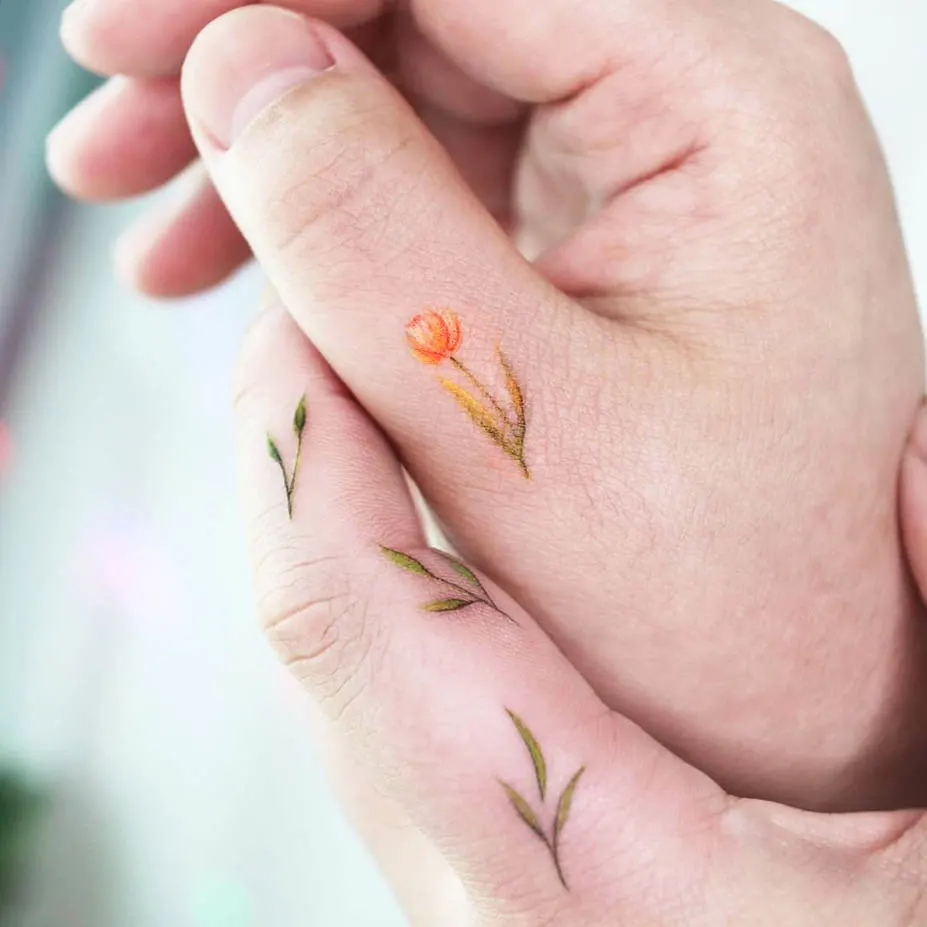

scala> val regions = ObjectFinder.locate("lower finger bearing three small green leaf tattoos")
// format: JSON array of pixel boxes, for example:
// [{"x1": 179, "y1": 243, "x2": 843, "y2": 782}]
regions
[{"x1": 236, "y1": 298, "x2": 725, "y2": 924}]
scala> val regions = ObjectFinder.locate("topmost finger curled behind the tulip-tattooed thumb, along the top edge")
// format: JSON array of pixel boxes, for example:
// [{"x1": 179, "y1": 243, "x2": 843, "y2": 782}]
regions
[{"x1": 62, "y1": 0, "x2": 700, "y2": 103}]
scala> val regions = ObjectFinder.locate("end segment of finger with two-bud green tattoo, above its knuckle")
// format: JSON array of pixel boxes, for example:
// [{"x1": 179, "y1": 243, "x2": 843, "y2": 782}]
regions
[{"x1": 234, "y1": 288, "x2": 421, "y2": 588}]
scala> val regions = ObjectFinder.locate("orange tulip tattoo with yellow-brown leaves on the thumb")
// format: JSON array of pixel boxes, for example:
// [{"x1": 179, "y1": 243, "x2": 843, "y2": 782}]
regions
[{"x1": 406, "y1": 309, "x2": 531, "y2": 479}]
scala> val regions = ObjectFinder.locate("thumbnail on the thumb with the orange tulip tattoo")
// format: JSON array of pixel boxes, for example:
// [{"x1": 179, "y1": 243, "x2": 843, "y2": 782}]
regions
[{"x1": 194, "y1": 8, "x2": 335, "y2": 148}]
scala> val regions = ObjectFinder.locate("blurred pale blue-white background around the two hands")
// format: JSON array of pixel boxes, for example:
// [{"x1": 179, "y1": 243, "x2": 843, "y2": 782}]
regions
[{"x1": 0, "y1": 0, "x2": 927, "y2": 927}]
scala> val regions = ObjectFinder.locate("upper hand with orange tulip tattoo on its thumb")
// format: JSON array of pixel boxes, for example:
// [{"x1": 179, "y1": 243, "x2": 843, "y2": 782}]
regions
[{"x1": 51, "y1": 0, "x2": 927, "y2": 809}]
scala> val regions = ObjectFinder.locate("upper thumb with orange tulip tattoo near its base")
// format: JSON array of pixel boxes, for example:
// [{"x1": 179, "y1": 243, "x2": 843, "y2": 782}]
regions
[{"x1": 183, "y1": 6, "x2": 607, "y2": 492}]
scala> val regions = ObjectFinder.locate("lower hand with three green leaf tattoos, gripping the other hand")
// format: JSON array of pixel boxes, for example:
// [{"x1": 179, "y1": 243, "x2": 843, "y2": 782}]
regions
[{"x1": 230, "y1": 306, "x2": 927, "y2": 927}]
